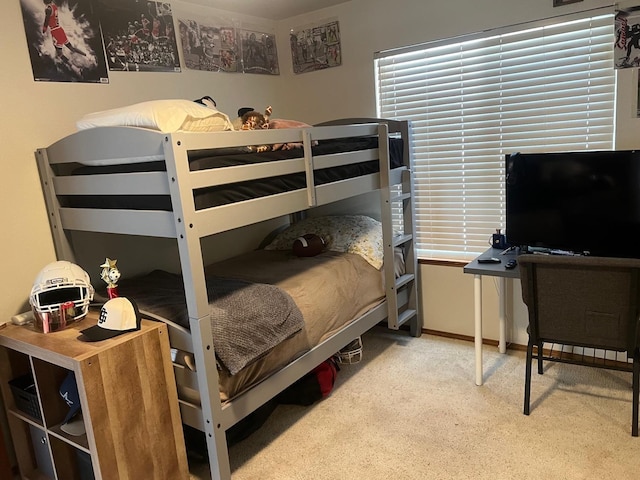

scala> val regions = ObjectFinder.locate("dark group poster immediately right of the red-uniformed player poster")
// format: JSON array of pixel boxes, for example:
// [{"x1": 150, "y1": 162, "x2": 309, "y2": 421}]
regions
[{"x1": 93, "y1": 0, "x2": 180, "y2": 72}]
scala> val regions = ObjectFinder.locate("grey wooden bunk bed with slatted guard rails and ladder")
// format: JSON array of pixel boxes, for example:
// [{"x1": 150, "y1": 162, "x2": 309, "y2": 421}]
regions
[{"x1": 36, "y1": 118, "x2": 422, "y2": 479}]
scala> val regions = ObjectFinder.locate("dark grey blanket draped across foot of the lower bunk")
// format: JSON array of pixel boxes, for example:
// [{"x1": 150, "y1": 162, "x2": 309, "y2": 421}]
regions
[{"x1": 109, "y1": 270, "x2": 304, "y2": 375}]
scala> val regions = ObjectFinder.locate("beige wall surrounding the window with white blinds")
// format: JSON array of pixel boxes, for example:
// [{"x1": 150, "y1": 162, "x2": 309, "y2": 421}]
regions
[{"x1": 278, "y1": 0, "x2": 640, "y2": 344}]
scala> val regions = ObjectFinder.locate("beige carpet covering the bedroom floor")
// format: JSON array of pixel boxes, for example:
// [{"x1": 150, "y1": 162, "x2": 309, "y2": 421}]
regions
[{"x1": 191, "y1": 328, "x2": 640, "y2": 480}]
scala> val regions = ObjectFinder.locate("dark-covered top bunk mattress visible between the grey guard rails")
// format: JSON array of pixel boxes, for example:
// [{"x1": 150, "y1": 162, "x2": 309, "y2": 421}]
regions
[{"x1": 58, "y1": 136, "x2": 404, "y2": 211}]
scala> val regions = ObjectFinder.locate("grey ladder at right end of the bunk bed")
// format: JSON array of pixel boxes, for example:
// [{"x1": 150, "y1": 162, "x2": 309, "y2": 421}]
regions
[{"x1": 379, "y1": 124, "x2": 422, "y2": 337}]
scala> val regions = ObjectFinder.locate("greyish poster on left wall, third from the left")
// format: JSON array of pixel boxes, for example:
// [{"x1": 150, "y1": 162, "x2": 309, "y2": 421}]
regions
[{"x1": 178, "y1": 19, "x2": 240, "y2": 72}]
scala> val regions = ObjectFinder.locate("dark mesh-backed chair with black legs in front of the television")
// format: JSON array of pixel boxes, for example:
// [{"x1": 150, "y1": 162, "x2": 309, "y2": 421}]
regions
[{"x1": 518, "y1": 254, "x2": 640, "y2": 437}]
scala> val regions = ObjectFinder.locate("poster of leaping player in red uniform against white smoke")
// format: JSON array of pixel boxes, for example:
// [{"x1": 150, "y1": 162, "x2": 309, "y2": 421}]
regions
[{"x1": 20, "y1": 0, "x2": 109, "y2": 83}]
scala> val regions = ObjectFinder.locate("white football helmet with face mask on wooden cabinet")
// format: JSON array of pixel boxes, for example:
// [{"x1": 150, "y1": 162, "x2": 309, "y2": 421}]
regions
[{"x1": 29, "y1": 260, "x2": 94, "y2": 333}]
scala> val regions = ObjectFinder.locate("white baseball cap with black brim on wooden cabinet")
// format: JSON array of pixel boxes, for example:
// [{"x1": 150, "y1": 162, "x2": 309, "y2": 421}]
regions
[{"x1": 80, "y1": 297, "x2": 141, "y2": 342}]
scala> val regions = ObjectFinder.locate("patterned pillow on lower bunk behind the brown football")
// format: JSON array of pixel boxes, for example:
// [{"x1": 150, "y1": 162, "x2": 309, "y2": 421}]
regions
[{"x1": 265, "y1": 215, "x2": 383, "y2": 270}]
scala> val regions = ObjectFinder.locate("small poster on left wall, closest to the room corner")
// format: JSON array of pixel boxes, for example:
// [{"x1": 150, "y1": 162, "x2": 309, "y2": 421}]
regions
[{"x1": 239, "y1": 29, "x2": 280, "y2": 75}]
